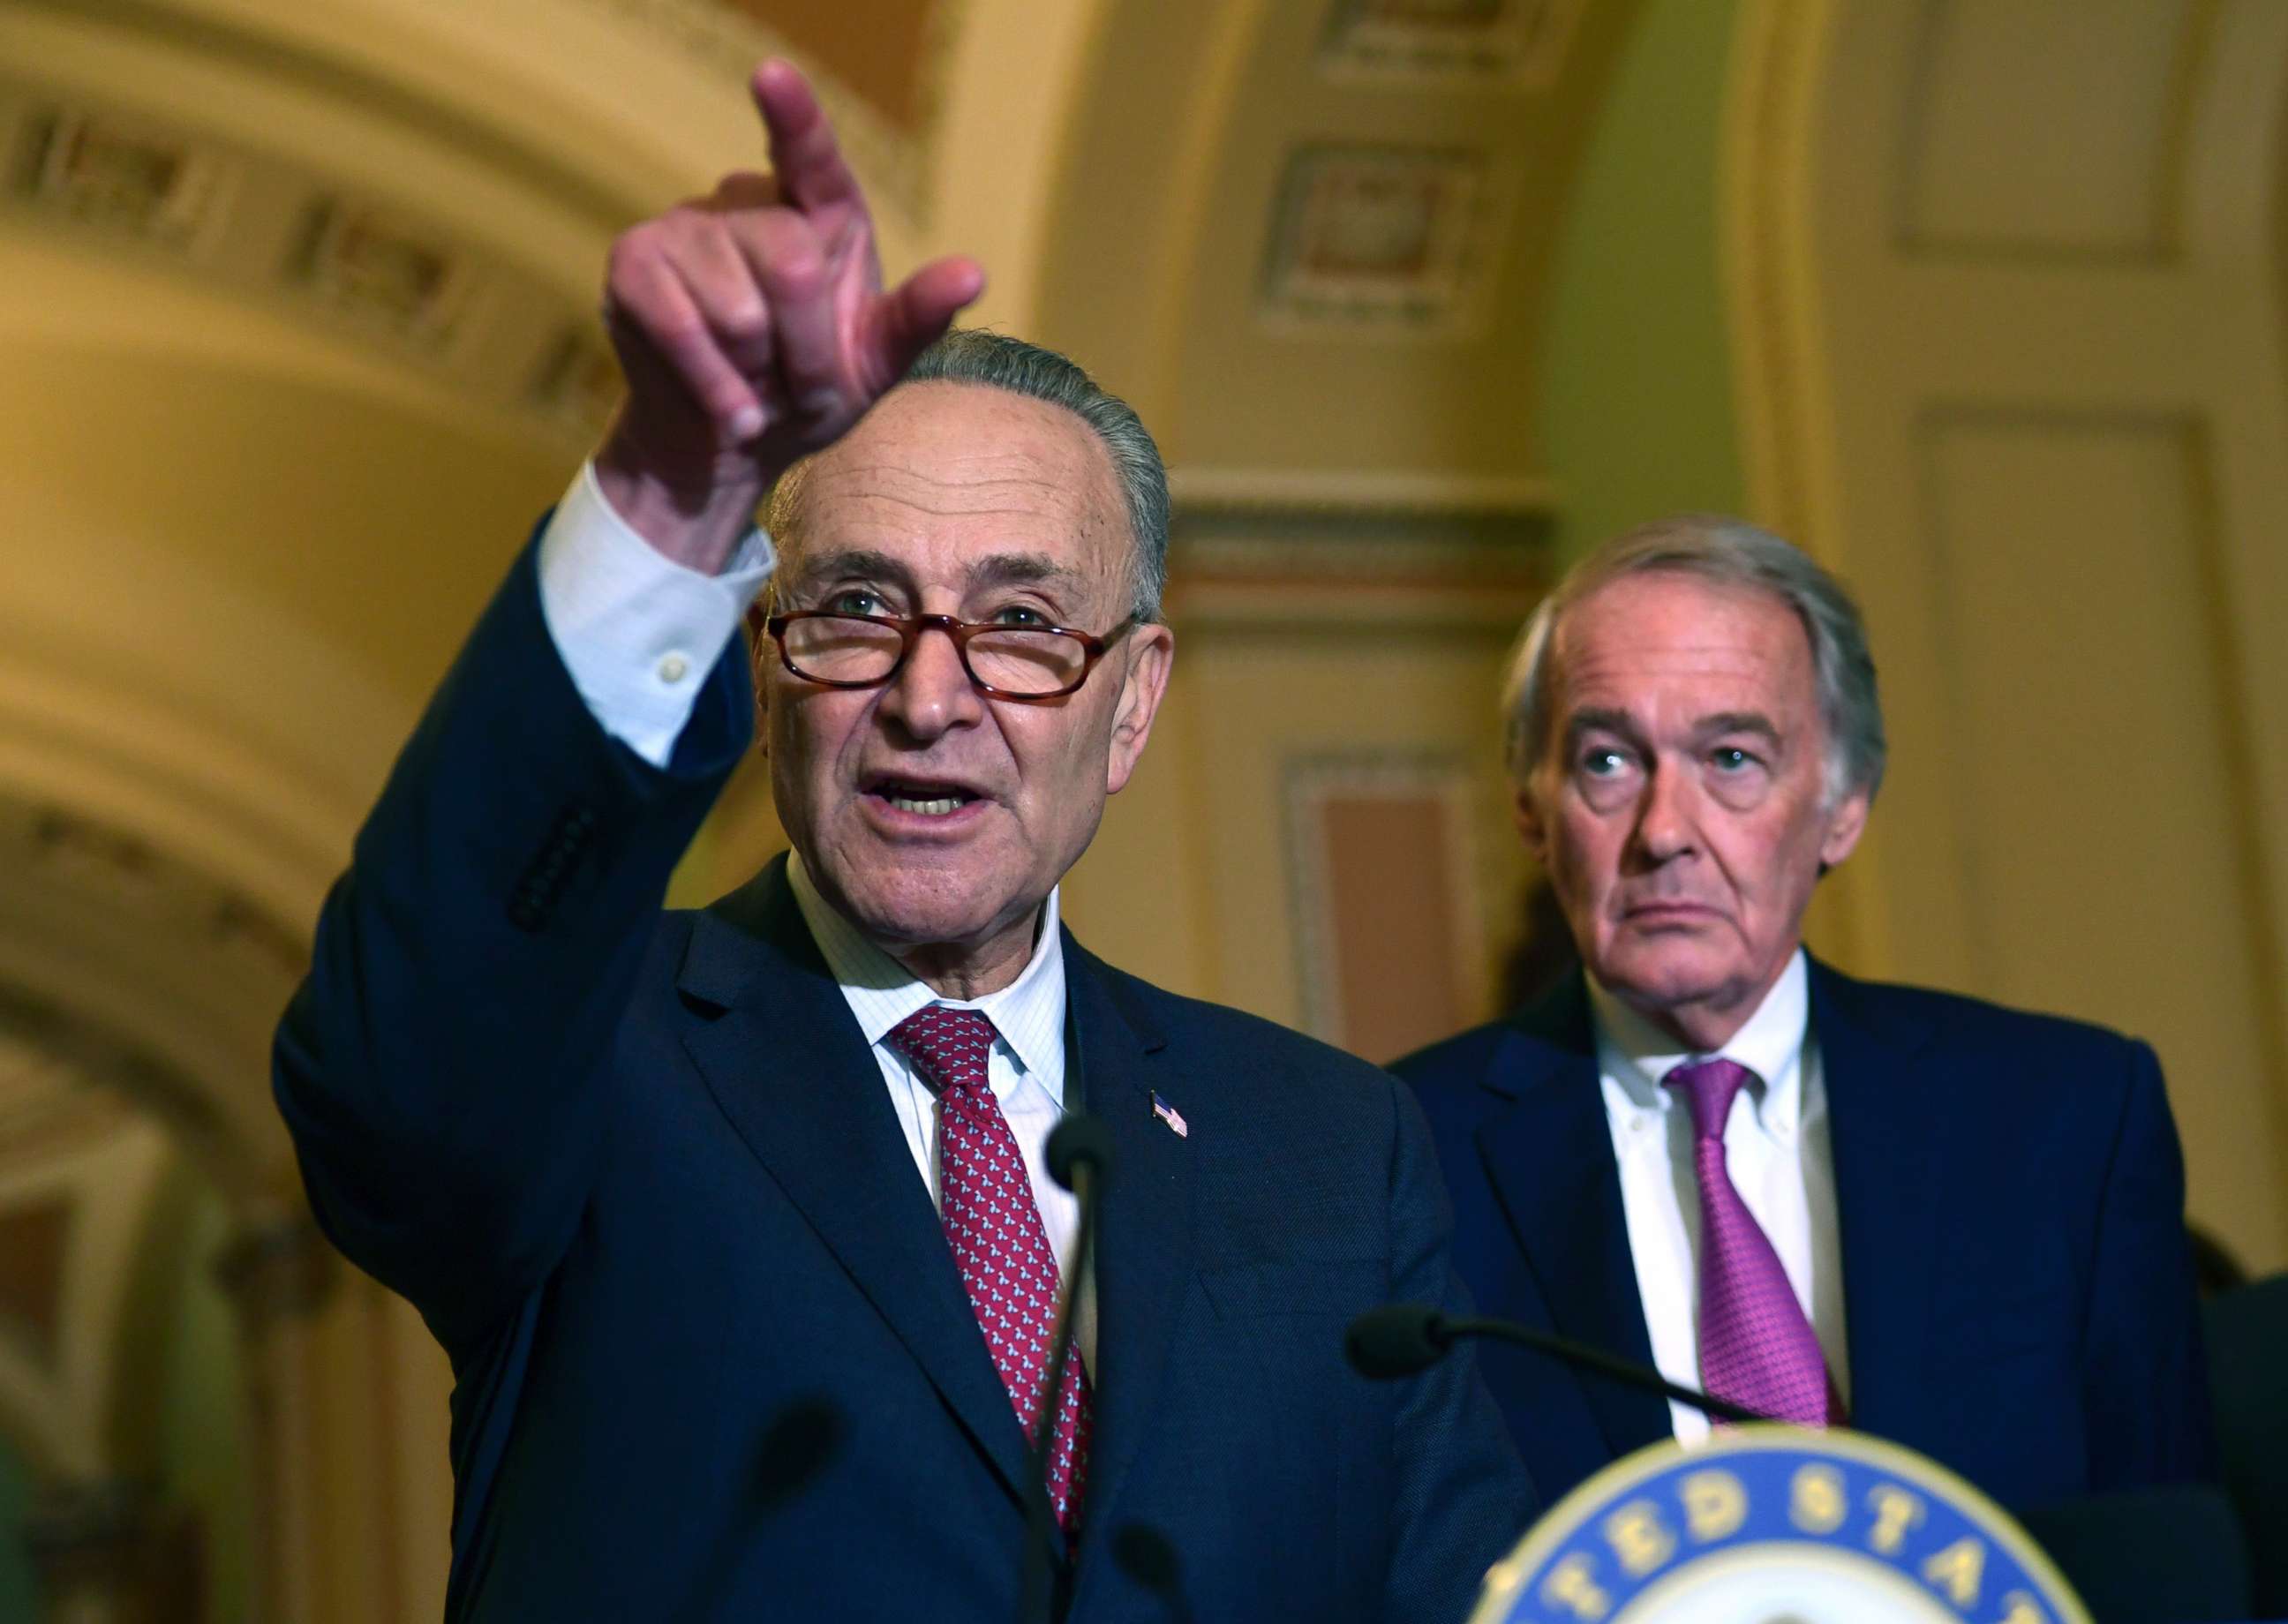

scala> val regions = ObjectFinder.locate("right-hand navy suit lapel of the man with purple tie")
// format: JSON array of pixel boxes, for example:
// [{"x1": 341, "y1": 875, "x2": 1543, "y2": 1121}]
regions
[{"x1": 1812, "y1": 960, "x2": 1945, "y2": 1430}]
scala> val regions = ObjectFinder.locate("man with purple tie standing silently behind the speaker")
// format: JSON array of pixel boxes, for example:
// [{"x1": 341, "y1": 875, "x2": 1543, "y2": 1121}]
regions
[{"x1": 1398, "y1": 519, "x2": 2212, "y2": 1505}]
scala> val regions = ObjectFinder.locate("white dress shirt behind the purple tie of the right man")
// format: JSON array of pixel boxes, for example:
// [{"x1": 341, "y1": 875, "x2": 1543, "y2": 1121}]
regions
[{"x1": 1588, "y1": 949, "x2": 1851, "y2": 1443}]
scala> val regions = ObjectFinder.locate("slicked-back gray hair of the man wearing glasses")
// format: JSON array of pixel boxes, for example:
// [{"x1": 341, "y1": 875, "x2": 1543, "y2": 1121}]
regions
[{"x1": 762, "y1": 327, "x2": 1167, "y2": 620}]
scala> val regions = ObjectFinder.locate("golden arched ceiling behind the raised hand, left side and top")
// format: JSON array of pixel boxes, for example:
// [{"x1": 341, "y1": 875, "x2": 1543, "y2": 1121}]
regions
[{"x1": 0, "y1": 0, "x2": 1634, "y2": 1457}]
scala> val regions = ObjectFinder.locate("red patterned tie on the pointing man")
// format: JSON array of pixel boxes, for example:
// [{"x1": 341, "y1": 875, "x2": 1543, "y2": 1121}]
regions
[{"x1": 890, "y1": 1004, "x2": 1089, "y2": 1535}]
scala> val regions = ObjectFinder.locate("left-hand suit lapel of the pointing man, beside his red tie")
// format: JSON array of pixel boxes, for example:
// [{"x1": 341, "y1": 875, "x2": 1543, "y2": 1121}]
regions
[{"x1": 677, "y1": 862, "x2": 1027, "y2": 1496}]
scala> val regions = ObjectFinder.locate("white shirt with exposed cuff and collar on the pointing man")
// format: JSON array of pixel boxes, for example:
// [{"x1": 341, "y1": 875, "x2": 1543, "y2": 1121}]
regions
[{"x1": 540, "y1": 462, "x2": 1096, "y2": 1370}]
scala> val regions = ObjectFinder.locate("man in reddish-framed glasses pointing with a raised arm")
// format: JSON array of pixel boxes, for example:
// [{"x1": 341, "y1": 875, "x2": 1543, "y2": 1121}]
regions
[{"x1": 277, "y1": 64, "x2": 1531, "y2": 1624}]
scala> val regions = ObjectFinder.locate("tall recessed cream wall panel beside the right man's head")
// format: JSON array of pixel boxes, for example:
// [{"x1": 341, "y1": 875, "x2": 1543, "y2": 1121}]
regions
[{"x1": 1924, "y1": 411, "x2": 2281, "y2": 1237}]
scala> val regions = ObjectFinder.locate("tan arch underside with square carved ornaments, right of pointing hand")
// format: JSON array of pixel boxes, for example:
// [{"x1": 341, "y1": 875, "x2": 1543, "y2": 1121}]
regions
[{"x1": 1039, "y1": 0, "x2": 1647, "y2": 508}]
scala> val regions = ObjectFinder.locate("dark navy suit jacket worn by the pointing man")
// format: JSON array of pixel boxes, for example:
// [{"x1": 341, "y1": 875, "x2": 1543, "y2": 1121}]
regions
[{"x1": 275, "y1": 539, "x2": 1531, "y2": 1624}]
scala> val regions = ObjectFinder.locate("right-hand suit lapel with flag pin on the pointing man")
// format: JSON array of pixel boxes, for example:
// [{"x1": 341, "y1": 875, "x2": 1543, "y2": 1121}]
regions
[{"x1": 1064, "y1": 933, "x2": 1199, "y2": 1583}]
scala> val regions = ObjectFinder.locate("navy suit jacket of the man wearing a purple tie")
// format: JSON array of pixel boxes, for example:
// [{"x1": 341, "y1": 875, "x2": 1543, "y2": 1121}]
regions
[{"x1": 1396, "y1": 960, "x2": 2215, "y2": 1507}]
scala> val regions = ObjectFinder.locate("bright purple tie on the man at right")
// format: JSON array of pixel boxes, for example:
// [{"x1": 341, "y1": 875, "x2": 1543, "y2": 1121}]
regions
[{"x1": 1661, "y1": 1059, "x2": 1842, "y2": 1427}]
